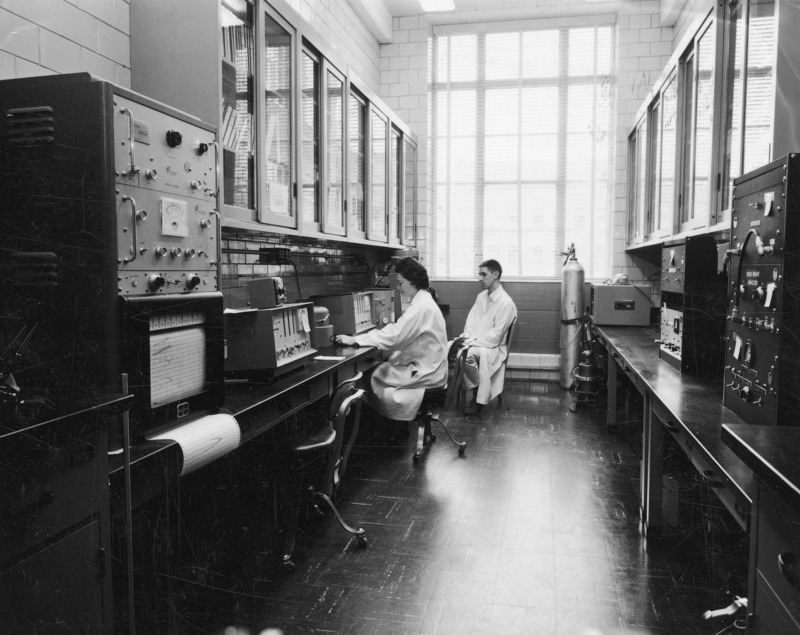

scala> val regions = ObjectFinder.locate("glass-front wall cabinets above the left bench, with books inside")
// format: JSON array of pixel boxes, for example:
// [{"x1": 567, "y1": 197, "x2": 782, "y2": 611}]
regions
[{"x1": 130, "y1": 0, "x2": 417, "y2": 247}]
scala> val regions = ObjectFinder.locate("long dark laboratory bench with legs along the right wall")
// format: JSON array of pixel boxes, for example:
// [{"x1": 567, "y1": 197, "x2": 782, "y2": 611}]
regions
[{"x1": 594, "y1": 326, "x2": 800, "y2": 635}]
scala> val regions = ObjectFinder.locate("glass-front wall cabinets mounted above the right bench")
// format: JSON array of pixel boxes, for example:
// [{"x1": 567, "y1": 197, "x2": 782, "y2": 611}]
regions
[{"x1": 628, "y1": 0, "x2": 800, "y2": 247}]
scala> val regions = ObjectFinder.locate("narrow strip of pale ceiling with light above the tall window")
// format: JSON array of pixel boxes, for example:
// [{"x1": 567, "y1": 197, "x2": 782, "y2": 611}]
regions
[{"x1": 383, "y1": 0, "x2": 640, "y2": 25}]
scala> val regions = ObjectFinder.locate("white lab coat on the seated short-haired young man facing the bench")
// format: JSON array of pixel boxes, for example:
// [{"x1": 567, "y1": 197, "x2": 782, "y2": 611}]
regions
[{"x1": 464, "y1": 285, "x2": 517, "y2": 404}]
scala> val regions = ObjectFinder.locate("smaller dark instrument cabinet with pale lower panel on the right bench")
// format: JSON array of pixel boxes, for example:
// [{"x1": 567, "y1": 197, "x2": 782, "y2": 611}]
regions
[{"x1": 658, "y1": 235, "x2": 727, "y2": 381}]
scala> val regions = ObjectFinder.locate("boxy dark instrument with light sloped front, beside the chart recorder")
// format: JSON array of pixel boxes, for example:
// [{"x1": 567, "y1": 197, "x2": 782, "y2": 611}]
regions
[{"x1": 224, "y1": 302, "x2": 317, "y2": 377}]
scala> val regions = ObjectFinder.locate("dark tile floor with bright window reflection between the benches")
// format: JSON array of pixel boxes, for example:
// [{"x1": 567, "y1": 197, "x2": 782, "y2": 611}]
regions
[{"x1": 144, "y1": 382, "x2": 748, "y2": 635}]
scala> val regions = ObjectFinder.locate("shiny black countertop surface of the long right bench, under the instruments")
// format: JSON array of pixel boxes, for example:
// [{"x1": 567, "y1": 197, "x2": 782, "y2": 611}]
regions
[{"x1": 595, "y1": 326, "x2": 755, "y2": 504}]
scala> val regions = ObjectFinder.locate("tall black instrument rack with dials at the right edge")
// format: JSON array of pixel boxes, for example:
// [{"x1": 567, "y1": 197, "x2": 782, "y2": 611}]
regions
[{"x1": 723, "y1": 154, "x2": 800, "y2": 425}]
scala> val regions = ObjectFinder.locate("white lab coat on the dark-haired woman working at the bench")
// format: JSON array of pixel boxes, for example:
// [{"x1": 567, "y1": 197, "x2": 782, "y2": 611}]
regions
[{"x1": 355, "y1": 290, "x2": 447, "y2": 421}]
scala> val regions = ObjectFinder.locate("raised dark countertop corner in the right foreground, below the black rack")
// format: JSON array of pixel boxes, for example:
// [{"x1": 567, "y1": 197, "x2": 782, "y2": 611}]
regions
[{"x1": 722, "y1": 423, "x2": 800, "y2": 514}]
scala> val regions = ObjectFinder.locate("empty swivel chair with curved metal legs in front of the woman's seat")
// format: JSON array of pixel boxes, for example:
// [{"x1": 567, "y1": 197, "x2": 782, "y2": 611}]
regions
[{"x1": 283, "y1": 373, "x2": 367, "y2": 572}]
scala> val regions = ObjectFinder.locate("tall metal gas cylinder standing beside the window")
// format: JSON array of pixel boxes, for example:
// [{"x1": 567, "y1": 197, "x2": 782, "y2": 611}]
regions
[{"x1": 559, "y1": 243, "x2": 586, "y2": 390}]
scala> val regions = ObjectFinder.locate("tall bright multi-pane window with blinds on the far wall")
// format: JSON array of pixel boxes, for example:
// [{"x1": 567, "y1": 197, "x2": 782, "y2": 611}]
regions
[{"x1": 430, "y1": 24, "x2": 615, "y2": 277}]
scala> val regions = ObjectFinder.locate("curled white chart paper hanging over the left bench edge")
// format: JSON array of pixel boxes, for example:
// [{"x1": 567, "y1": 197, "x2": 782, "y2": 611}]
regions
[{"x1": 147, "y1": 414, "x2": 242, "y2": 476}]
